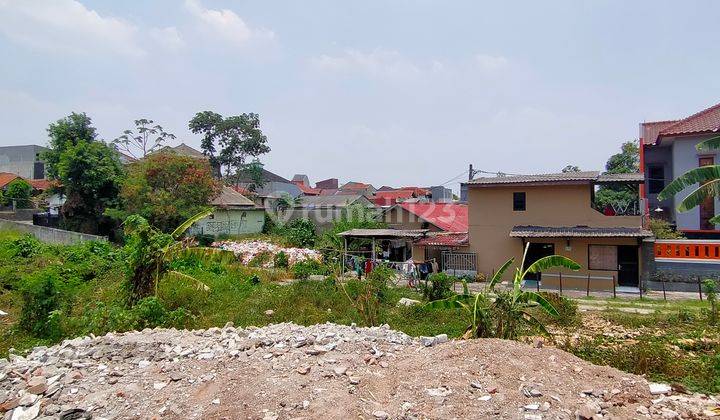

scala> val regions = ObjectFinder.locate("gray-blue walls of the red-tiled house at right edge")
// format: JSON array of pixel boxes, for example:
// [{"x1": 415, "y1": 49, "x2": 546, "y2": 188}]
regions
[{"x1": 663, "y1": 136, "x2": 720, "y2": 230}]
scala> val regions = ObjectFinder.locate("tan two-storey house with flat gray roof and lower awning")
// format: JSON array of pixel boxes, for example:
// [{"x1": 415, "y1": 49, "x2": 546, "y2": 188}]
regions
[{"x1": 466, "y1": 172, "x2": 652, "y2": 290}]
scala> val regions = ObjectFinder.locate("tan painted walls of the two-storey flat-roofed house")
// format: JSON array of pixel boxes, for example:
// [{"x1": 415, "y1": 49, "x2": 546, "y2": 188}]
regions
[{"x1": 468, "y1": 185, "x2": 642, "y2": 279}]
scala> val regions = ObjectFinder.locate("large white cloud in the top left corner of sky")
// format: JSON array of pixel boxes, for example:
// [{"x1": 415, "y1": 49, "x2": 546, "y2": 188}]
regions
[{"x1": 0, "y1": 0, "x2": 145, "y2": 56}]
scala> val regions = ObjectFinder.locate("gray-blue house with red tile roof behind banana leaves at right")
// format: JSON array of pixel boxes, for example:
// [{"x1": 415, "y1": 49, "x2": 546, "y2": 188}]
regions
[{"x1": 640, "y1": 104, "x2": 720, "y2": 239}]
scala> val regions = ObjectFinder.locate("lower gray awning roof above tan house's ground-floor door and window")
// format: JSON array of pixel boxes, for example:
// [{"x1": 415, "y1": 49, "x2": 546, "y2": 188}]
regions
[{"x1": 510, "y1": 226, "x2": 653, "y2": 238}]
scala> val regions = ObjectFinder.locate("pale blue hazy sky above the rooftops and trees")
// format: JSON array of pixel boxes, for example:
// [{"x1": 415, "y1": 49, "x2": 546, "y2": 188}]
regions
[{"x1": 0, "y1": 0, "x2": 720, "y2": 191}]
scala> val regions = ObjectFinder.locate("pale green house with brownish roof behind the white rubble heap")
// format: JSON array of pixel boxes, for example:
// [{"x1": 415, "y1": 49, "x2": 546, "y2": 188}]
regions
[{"x1": 189, "y1": 186, "x2": 265, "y2": 236}]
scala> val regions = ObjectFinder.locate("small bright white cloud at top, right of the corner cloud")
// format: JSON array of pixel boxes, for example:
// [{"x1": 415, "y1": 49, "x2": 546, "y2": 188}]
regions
[{"x1": 185, "y1": 0, "x2": 275, "y2": 46}]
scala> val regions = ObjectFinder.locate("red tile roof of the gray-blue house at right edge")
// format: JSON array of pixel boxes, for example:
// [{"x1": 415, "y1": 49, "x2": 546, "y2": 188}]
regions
[{"x1": 643, "y1": 104, "x2": 720, "y2": 144}]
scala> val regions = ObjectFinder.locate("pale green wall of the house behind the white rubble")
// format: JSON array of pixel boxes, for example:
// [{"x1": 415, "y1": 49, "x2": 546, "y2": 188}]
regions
[{"x1": 189, "y1": 209, "x2": 265, "y2": 236}]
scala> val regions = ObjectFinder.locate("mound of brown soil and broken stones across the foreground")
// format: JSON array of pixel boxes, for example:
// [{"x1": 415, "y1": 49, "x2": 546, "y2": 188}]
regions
[{"x1": 0, "y1": 324, "x2": 720, "y2": 420}]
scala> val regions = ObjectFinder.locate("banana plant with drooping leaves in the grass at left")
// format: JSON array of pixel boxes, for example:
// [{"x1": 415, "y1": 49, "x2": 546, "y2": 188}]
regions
[{"x1": 124, "y1": 209, "x2": 232, "y2": 301}]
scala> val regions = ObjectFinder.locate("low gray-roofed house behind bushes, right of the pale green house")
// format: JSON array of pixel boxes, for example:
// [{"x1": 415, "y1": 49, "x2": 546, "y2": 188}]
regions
[{"x1": 288, "y1": 194, "x2": 375, "y2": 231}]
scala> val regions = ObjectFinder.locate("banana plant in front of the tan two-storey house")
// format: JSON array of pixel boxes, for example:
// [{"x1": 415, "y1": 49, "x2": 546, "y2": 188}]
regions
[{"x1": 427, "y1": 243, "x2": 580, "y2": 339}]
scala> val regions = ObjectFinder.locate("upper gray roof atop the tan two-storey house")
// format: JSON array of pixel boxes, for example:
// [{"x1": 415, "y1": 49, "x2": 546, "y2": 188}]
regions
[{"x1": 468, "y1": 171, "x2": 644, "y2": 186}]
